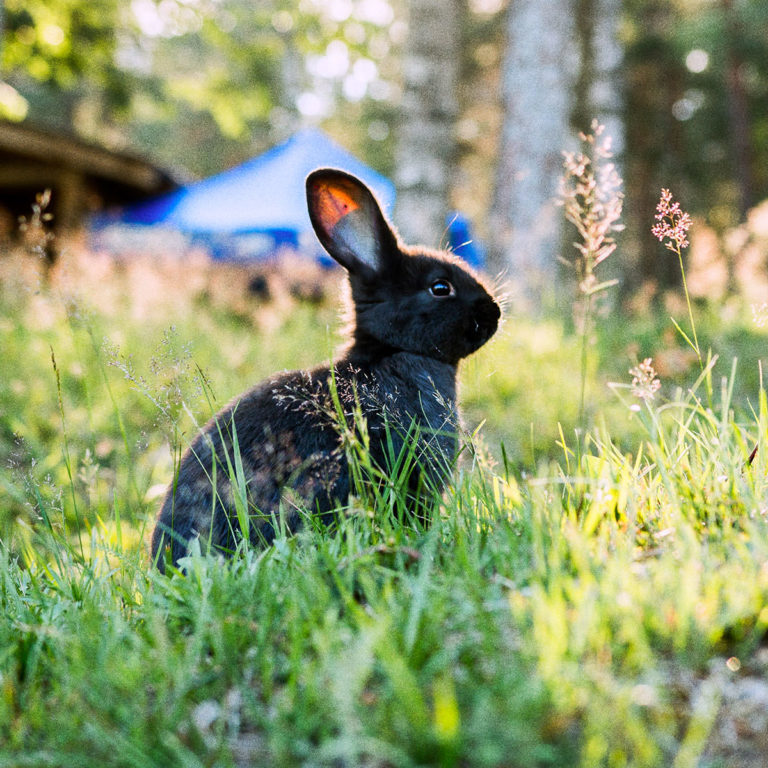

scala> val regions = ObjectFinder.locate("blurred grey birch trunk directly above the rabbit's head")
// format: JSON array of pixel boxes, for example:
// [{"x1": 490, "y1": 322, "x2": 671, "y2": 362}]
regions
[{"x1": 394, "y1": 0, "x2": 460, "y2": 247}]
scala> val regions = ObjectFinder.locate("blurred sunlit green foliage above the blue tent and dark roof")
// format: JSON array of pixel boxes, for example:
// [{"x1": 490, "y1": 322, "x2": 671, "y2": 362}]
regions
[{"x1": 0, "y1": 0, "x2": 404, "y2": 175}]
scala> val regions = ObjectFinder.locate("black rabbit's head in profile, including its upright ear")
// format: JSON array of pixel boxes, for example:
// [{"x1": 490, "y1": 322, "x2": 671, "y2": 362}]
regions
[{"x1": 307, "y1": 168, "x2": 501, "y2": 363}]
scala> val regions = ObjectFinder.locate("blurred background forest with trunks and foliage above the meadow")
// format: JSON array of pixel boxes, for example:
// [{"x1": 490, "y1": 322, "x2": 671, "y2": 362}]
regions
[{"x1": 0, "y1": 0, "x2": 768, "y2": 300}]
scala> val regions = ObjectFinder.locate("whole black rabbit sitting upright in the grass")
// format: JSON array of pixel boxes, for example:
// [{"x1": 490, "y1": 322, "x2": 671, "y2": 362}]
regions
[{"x1": 152, "y1": 168, "x2": 501, "y2": 570}]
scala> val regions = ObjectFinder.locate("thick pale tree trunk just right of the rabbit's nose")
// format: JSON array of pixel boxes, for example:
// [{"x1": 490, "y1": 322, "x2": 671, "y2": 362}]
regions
[{"x1": 491, "y1": 0, "x2": 575, "y2": 290}]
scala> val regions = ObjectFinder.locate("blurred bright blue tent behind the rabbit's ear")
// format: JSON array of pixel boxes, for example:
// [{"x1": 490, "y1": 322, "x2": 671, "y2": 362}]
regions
[{"x1": 103, "y1": 129, "x2": 395, "y2": 258}]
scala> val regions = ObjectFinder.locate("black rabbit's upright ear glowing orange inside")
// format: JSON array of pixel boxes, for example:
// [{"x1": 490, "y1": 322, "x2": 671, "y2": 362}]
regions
[{"x1": 307, "y1": 168, "x2": 396, "y2": 274}]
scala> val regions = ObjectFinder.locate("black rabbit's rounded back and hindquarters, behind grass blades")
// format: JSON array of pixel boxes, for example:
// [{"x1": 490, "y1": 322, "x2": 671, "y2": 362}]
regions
[{"x1": 152, "y1": 366, "x2": 348, "y2": 567}]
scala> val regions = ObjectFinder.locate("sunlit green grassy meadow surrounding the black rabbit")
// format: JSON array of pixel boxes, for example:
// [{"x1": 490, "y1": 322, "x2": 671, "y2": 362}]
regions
[{"x1": 0, "y1": 236, "x2": 768, "y2": 768}]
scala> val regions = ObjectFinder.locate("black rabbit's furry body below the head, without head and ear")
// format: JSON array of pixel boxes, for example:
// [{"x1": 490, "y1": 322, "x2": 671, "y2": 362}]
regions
[{"x1": 153, "y1": 352, "x2": 457, "y2": 563}]
